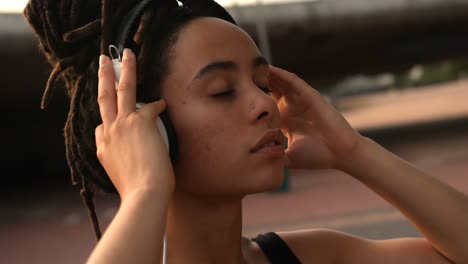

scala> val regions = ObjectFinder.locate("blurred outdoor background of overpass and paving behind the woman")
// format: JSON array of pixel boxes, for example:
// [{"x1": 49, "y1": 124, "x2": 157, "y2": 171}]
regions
[{"x1": 0, "y1": 0, "x2": 468, "y2": 263}]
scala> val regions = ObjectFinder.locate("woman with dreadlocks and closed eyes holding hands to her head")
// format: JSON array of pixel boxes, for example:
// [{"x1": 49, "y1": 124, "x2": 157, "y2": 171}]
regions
[{"x1": 25, "y1": 0, "x2": 468, "y2": 263}]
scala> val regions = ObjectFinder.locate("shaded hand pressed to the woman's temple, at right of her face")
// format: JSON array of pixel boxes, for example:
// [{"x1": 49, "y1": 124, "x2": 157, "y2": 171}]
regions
[{"x1": 270, "y1": 66, "x2": 362, "y2": 169}]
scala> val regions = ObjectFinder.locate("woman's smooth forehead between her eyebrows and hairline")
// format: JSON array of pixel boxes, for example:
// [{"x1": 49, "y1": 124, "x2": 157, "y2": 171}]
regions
[{"x1": 171, "y1": 18, "x2": 260, "y2": 77}]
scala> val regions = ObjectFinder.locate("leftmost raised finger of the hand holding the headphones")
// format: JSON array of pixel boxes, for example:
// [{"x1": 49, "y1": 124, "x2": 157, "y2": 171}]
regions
[{"x1": 98, "y1": 55, "x2": 117, "y2": 124}]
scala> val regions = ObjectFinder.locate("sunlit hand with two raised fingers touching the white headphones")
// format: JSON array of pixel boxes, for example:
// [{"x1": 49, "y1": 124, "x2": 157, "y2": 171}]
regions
[{"x1": 95, "y1": 49, "x2": 175, "y2": 200}]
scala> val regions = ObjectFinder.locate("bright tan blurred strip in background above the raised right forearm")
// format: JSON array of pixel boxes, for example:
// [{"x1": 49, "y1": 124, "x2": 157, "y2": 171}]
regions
[{"x1": 334, "y1": 79, "x2": 468, "y2": 131}]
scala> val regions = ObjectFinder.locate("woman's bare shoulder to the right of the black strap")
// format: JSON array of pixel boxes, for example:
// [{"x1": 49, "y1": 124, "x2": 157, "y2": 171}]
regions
[{"x1": 277, "y1": 229, "x2": 450, "y2": 264}]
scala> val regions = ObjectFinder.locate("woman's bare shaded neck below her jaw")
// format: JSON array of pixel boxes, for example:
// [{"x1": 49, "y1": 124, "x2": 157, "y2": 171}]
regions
[{"x1": 166, "y1": 191, "x2": 243, "y2": 264}]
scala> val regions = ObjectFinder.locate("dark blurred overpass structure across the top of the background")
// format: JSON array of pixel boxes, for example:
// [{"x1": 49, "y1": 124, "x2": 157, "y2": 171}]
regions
[{"x1": 0, "y1": 0, "x2": 468, "y2": 101}]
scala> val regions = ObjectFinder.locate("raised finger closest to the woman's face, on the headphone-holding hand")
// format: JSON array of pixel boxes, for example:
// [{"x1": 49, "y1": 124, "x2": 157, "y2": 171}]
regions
[{"x1": 117, "y1": 49, "x2": 136, "y2": 116}]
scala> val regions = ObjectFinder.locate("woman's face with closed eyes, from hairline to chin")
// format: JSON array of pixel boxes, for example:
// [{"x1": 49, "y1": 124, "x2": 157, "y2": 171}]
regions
[{"x1": 163, "y1": 18, "x2": 285, "y2": 196}]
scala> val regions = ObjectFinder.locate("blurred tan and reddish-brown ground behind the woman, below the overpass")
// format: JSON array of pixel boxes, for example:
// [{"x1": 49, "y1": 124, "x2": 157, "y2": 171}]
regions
[{"x1": 0, "y1": 79, "x2": 468, "y2": 264}]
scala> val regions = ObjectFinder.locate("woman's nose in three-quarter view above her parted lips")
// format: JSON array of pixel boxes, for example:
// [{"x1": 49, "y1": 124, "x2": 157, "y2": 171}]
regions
[{"x1": 246, "y1": 86, "x2": 279, "y2": 126}]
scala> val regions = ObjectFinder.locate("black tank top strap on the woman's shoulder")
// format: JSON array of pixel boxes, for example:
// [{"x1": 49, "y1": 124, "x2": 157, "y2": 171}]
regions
[{"x1": 253, "y1": 232, "x2": 301, "y2": 264}]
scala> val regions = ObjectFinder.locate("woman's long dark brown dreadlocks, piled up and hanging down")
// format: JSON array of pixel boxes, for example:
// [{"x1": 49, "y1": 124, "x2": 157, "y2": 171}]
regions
[{"x1": 23, "y1": 0, "x2": 236, "y2": 240}]
